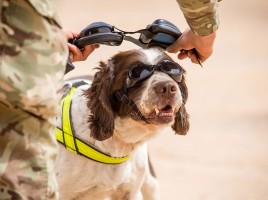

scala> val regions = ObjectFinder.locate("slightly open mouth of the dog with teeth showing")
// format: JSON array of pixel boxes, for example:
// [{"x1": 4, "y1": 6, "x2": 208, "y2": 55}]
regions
[{"x1": 132, "y1": 105, "x2": 175, "y2": 124}]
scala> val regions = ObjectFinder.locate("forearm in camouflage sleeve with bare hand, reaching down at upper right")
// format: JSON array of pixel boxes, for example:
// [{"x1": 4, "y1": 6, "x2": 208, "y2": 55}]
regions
[{"x1": 167, "y1": 0, "x2": 219, "y2": 63}]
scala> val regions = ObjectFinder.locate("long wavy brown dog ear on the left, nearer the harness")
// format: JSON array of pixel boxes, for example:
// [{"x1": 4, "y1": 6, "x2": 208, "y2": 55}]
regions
[{"x1": 85, "y1": 62, "x2": 114, "y2": 141}]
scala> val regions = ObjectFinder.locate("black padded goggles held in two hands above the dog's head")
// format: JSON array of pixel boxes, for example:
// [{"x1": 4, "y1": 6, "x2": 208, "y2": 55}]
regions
[{"x1": 67, "y1": 19, "x2": 202, "y2": 71}]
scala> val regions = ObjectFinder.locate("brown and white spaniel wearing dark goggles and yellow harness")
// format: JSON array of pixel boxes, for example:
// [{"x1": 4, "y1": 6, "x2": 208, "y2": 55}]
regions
[{"x1": 56, "y1": 48, "x2": 189, "y2": 200}]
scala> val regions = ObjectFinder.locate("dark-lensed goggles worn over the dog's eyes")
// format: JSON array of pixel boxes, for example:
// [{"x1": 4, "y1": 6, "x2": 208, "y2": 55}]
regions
[{"x1": 127, "y1": 60, "x2": 183, "y2": 88}]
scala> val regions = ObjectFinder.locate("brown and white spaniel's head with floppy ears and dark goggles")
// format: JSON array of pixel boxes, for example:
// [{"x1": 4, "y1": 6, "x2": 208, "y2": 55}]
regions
[{"x1": 85, "y1": 49, "x2": 189, "y2": 140}]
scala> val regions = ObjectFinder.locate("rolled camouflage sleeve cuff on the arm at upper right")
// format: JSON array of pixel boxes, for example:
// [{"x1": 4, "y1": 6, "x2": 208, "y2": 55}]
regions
[{"x1": 177, "y1": 0, "x2": 219, "y2": 36}]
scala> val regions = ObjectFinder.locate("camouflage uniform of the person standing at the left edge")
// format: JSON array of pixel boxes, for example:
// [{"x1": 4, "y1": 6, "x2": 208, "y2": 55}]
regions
[{"x1": 0, "y1": 0, "x2": 68, "y2": 200}]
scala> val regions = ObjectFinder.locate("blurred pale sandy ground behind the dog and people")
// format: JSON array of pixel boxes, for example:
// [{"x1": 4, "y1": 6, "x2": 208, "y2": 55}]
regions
[{"x1": 57, "y1": 0, "x2": 268, "y2": 200}]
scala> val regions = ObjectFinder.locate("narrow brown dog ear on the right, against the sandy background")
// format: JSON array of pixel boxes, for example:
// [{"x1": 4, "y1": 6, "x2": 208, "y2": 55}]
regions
[{"x1": 172, "y1": 75, "x2": 190, "y2": 135}]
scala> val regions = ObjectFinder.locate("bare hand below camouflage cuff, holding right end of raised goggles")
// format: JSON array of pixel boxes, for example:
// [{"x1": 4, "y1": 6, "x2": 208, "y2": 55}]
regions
[{"x1": 167, "y1": 29, "x2": 216, "y2": 64}]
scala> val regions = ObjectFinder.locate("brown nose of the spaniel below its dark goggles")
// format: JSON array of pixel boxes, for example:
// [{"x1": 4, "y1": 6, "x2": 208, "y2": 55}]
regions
[{"x1": 155, "y1": 81, "x2": 177, "y2": 98}]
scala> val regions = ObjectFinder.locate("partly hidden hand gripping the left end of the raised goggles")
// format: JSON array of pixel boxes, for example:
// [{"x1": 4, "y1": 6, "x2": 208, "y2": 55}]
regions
[{"x1": 63, "y1": 30, "x2": 100, "y2": 62}]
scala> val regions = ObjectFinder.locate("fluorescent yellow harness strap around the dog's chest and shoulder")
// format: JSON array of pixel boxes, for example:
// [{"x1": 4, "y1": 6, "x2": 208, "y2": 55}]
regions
[{"x1": 55, "y1": 82, "x2": 129, "y2": 164}]
